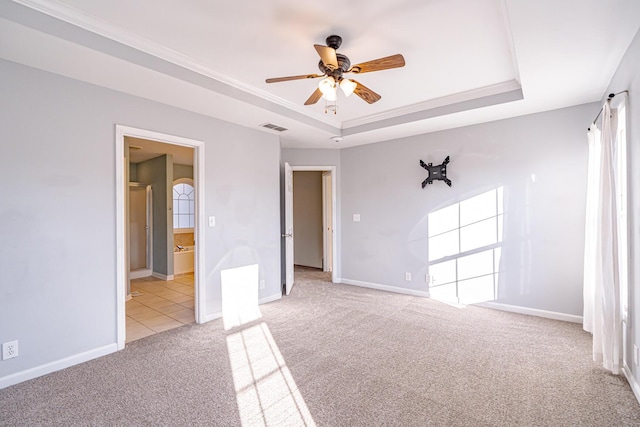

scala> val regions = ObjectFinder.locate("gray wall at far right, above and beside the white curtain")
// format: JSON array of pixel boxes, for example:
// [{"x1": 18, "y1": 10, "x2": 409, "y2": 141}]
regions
[{"x1": 603, "y1": 25, "x2": 640, "y2": 388}]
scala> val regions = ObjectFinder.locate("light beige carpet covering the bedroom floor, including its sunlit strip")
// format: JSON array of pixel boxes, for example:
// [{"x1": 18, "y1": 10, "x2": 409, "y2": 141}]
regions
[{"x1": 0, "y1": 269, "x2": 640, "y2": 426}]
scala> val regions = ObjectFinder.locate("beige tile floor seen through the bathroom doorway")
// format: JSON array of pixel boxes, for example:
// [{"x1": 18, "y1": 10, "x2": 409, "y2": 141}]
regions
[{"x1": 126, "y1": 273, "x2": 195, "y2": 342}]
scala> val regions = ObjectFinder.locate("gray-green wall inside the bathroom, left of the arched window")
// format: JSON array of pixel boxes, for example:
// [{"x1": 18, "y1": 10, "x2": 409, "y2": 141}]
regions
[{"x1": 136, "y1": 154, "x2": 174, "y2": 276}]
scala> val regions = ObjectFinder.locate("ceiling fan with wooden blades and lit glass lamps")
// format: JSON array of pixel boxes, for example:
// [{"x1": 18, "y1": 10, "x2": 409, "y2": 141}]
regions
[{"x1": 266, "y1": 35, "x2": 404, "y2": 105}]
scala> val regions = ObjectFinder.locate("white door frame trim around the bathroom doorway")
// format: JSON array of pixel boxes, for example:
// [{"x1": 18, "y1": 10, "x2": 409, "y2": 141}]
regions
[{"x1": 115, "y1": 124, "x2": 206, "y2": 350}]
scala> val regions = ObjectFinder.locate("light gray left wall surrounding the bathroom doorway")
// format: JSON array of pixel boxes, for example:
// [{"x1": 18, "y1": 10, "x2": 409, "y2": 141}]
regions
[{"x1": 0, "y1": 60, "x2": 280, "y2": 386}]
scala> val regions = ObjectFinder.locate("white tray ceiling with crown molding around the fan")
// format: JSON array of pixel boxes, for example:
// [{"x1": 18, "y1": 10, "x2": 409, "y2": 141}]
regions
[{"x1": 0, "y1": 0, "x2": 640, "y2": 148}]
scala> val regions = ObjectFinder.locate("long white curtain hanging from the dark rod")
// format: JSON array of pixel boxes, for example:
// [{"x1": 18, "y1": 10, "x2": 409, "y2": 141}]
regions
[{"x1": 583, "y1": 102, "x2": 622, "y2": 374}]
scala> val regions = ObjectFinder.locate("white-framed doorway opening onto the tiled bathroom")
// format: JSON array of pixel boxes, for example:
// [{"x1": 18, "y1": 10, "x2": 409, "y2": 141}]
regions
[{"x1": 116, "y1": 126, "x2": 204, "y2": 349}]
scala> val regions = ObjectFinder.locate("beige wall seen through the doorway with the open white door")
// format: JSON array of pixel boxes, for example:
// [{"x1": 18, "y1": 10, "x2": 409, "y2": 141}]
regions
[{"x1": 293, "y1": 171, "x2": 323, "y2": 268}]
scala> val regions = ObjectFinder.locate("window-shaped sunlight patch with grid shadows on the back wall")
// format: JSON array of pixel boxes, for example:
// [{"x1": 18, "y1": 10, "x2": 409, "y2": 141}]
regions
[{"x1": 428, "y1": 187, "x2": 504, "y2": 304}]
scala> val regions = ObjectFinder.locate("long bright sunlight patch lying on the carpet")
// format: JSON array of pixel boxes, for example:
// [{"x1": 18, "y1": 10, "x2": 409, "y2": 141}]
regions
[{"x1": 227, "y1": 323, "x2": 316, "y2": 426}]
